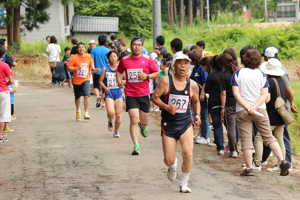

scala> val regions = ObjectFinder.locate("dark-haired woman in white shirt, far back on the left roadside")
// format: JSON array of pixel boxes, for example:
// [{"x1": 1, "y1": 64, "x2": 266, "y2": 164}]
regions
[{"x1": 46, "y1": 35, "x2": 61, "y2": 84}]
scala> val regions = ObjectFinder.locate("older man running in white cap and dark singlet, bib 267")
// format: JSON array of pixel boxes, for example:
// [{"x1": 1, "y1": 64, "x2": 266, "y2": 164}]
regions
[{"x1": 152, "y1": 54, "x2": 201, "y2": 193}]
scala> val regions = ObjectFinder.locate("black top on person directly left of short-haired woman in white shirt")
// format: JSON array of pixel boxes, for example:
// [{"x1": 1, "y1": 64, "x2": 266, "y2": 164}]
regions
[{"x1": 220, "y1": 69, "x2": 236, "y2": 106}]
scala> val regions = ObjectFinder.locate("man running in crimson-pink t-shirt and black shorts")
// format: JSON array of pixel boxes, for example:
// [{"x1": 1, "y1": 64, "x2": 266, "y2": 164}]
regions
[{"x1": 116, "y1": 37, "x2": 159, "y2": 155}]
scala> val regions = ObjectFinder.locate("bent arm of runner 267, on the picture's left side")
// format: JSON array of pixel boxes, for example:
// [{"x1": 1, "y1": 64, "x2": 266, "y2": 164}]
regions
[{"x1": 151, "y1": 77, "x2": 177, "y2": 115}]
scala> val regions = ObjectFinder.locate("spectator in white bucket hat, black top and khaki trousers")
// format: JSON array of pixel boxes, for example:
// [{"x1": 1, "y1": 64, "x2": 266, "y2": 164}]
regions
[{"x1": 255, "y1": 58, "x2": 287, "y2": 171}]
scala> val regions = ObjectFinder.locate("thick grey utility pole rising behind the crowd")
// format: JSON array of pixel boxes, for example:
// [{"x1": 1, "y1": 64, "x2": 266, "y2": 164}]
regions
[{"x1": 152, "y1": 0, "x2": 161, "y2": 49}]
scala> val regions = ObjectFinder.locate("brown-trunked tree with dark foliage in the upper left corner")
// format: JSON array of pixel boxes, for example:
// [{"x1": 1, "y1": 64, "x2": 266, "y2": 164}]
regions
[{"x1": 0, "y1": 0, "x2": 51, "y2": 48}]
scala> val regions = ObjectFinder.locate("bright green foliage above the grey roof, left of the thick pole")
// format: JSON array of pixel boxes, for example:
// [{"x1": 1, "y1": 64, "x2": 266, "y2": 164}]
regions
[{"x1": 74, "y1": 0, "x2": 152, "y2": 38}]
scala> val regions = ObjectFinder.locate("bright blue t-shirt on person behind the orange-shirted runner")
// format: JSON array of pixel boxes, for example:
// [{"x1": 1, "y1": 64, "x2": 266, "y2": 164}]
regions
[{"x1": 91, "y1": 46, "x2": 110, "y2": 75}]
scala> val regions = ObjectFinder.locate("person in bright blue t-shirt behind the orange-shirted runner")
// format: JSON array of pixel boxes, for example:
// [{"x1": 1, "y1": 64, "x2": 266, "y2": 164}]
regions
[{"x1": 91, "y1": 35, "x2": 109, "y2": 109}]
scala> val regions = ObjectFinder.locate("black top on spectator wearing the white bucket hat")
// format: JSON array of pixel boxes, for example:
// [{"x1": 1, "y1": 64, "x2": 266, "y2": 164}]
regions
[{"x1": 267, "y1": 77, "x2": 287, "y2": 126}]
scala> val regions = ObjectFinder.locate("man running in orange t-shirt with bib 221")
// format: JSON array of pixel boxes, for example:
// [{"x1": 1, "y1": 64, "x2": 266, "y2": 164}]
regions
[{"x1": 67, "y1": 42, "x2": 100, "y2": 121}]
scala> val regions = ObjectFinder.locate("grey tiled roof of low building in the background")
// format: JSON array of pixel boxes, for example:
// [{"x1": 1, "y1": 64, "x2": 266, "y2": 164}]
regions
[{"x1": 70, "y1": 15, "x2": 119, "y2": 33}]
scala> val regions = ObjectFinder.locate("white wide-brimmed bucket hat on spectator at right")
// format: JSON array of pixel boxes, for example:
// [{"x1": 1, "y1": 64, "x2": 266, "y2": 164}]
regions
[{"x1": 260, "y1": 58, "x2": 285, "y2": 76}]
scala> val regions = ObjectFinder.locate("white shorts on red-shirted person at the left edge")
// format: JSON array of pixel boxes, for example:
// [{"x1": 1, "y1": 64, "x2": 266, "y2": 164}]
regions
[{"x1": 0, "y1": 91, "x2": 11, "y2": 123}]
